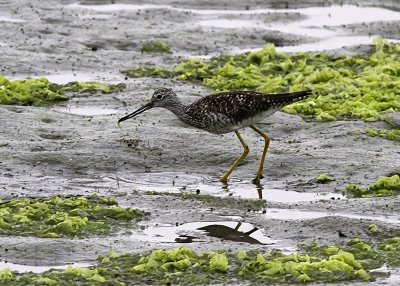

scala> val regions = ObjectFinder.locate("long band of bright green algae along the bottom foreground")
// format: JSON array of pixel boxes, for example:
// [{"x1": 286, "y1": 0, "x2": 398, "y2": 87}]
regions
[{"x1": 0, "y1": 244, "x2": 374, "y2": 286}]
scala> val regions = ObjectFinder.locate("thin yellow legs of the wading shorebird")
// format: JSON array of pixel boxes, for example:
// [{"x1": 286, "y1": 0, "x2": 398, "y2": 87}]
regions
[{"x1": 220, "y1": 125, "x2": 270, "y2": 184}]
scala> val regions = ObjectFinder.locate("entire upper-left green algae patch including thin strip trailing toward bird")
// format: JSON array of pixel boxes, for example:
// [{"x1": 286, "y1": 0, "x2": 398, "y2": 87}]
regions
[{"x1": 0, "y1": 76, "x2": 126, "y2": 106}]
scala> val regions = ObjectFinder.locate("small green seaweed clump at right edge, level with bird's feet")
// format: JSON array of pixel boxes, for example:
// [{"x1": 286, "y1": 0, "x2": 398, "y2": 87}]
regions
[{"x1": 346, "y1": 175, "x2": 400, "y2": 198}]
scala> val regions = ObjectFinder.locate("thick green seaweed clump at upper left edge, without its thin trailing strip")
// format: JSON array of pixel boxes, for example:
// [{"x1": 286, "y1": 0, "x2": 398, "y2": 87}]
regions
[{"x1": 0, "y1": 76, "x2": 69, "y2": 106}]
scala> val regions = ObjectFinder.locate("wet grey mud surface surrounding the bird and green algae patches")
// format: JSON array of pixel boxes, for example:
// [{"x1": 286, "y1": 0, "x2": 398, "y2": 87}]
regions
[{"x1": 0, "y1": 1, "x2": 400, "y2": 283}]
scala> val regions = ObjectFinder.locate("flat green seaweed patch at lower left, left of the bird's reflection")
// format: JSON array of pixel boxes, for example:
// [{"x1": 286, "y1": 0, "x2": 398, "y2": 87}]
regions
[{"x1": 0, "y1": 195, "x2": 145, "y2": 238}]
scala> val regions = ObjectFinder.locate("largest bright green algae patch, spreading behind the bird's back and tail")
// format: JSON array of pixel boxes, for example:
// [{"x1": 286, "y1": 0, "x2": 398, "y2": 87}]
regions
[{"x1": 125, "y1": 39, "x2": 400, "y2": 121}]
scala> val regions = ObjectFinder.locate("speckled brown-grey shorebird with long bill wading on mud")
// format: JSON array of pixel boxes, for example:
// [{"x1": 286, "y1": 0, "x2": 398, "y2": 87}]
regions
[{"x1": 118, "y1": 88, "x2": 311, "y2": 184}]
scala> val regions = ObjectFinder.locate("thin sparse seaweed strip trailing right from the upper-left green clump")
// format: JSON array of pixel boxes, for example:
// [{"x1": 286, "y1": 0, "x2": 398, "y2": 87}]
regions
[{"x1": 59, "y1": 81, "x2": 126, "y2": 93}]
